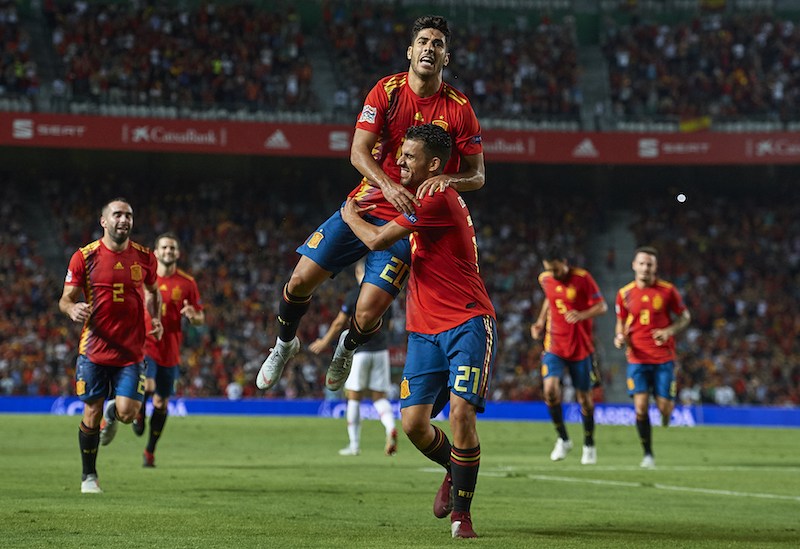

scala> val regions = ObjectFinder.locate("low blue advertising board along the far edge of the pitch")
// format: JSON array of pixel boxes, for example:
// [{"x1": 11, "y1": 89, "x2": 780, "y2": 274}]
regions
[{"x1": 0, "y1": 397, "x2": 800, "y2": 428}]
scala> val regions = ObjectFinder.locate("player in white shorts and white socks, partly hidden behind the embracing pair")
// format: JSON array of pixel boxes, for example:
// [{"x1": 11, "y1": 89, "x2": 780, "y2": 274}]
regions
[{"x1": 308, "y1": 259, "x2": 397, "y2": 456}]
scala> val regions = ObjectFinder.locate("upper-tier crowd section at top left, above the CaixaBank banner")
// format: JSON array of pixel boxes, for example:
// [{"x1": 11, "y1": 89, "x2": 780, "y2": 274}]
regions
[{"x1": 45, "y1": 1, "x2": 316, "y2": 111}]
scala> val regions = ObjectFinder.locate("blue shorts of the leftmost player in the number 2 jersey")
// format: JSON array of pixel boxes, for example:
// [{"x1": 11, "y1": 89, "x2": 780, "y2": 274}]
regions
[{"x1": 75, "y1": 355, "x2": 144, "y2": 402}]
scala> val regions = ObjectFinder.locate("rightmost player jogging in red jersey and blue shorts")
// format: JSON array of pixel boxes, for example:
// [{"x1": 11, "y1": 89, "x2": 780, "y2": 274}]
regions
[{"x1": 614, "y1": 246, "x2": 692, "y2": 469}]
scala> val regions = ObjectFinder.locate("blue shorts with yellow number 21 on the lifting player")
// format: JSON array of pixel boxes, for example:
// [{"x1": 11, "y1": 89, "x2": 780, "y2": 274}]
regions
[{"x1": 400, "y1": 315, "x2": 497, "y2": 415}]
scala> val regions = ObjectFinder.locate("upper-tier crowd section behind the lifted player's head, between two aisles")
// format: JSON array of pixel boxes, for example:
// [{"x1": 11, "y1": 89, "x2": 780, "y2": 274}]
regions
[{"x1": 323, "y1": 2, "x2": 582, "y2": 119}]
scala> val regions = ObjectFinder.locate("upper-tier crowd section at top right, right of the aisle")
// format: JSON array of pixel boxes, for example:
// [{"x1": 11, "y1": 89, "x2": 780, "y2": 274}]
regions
[{"x1": 603, "y1": 13, "x2": 800, "y2": 120}]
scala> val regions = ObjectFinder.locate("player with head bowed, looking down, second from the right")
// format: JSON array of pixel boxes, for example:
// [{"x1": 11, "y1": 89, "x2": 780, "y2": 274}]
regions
[{"x1": 531, "y1": 245, "x2": 608, "y2": 465}]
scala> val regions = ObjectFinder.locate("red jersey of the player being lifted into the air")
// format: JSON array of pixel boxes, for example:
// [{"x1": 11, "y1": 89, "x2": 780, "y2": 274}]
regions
[{"x1": 349, "y1": 72, "x2": 483, "y2": 221}]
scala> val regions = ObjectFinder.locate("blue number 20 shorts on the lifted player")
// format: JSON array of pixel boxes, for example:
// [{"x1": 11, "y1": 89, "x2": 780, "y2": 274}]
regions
[{"x1": 297, "y1": 210, "x2": 411, "y2": 297}]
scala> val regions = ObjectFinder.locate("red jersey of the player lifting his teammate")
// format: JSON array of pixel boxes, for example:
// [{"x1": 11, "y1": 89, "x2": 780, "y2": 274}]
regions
[{"x1": 394, "y1": 187, "x2": 495, "y2": 334}]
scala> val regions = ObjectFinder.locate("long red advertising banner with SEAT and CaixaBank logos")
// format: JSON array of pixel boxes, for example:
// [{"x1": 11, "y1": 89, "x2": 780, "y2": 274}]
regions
[{"x1": 0, "y1": 112, "x2": 800, "y2": 165}]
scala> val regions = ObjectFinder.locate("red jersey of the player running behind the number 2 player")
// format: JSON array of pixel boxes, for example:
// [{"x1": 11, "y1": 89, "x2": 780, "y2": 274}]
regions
[{"x1": 145, "y1": 269, "x2": 203, "y2": 368}]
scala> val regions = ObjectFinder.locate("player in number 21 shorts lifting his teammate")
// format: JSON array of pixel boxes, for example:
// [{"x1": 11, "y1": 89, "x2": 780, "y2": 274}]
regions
[{"x1": 342, "y1": 124, "x2": 497, "y2": 538}]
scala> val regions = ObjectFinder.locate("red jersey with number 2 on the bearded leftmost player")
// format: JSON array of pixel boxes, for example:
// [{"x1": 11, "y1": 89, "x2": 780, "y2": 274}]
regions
[{"x1": 64, "y1": 240, "x2": 157, "y2": 366}]
